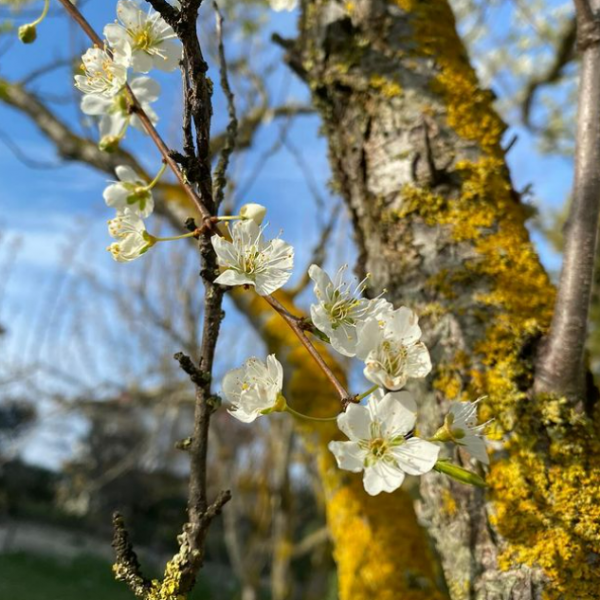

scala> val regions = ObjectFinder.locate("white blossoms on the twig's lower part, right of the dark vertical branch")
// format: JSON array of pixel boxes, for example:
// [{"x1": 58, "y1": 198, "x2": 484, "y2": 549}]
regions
[{"x1": 217, "y1": 215, "x2": 488, "y2": 495}]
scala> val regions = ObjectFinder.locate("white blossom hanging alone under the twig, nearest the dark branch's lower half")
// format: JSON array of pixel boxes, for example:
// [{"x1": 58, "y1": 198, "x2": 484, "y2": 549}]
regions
[{"x1": 222, "y1": 354, "x2": 285, "y2": 423}]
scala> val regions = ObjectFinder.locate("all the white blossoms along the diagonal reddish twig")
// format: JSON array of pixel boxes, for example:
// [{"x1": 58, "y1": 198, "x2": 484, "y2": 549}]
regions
[{"x1": 75, "y1": 0, "x2": 488, "y2": 495}]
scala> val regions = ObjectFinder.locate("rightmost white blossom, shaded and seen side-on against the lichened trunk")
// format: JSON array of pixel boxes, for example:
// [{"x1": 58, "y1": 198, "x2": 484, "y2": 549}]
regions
[{"x1": 435, "y1": 398, "x2": 490, "y2": 465}]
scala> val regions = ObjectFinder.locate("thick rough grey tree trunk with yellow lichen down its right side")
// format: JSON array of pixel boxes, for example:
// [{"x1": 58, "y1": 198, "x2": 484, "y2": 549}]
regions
[{"x1": 280, "y1": 0, "x2": 600, "y2": 600}]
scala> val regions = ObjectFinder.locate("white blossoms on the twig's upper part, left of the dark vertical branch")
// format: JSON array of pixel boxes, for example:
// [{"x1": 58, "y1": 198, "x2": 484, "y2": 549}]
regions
[{"x1": 75, "y1": 0, "x2": 182, "y2": 262}]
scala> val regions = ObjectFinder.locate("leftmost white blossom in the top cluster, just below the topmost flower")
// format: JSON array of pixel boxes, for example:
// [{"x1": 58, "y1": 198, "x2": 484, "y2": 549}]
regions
[{"x1": 75, "y1": 47, "x2": 128, "y2": 98}]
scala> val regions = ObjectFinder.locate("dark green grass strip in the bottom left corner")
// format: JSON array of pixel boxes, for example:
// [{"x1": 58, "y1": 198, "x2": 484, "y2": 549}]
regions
[{"x1": 0, "y1": 553, "x2": 210, "y2": 600}]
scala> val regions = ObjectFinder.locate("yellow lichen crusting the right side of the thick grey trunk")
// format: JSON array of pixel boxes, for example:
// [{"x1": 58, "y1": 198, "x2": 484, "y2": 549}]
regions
[{"x1": 396, "y1": 0, "x2": 600, "y2": 600}]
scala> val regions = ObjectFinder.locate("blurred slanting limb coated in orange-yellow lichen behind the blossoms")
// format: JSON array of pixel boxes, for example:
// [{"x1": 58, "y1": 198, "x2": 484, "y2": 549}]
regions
[{"x1": 233, "y1": 289, "x2": 444, "y2": 600}]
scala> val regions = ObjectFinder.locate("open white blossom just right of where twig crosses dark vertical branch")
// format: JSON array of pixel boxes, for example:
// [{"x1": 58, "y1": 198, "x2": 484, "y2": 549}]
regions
[{"x1": 211, "y1": 219, "x2": 294, "y2": 296}]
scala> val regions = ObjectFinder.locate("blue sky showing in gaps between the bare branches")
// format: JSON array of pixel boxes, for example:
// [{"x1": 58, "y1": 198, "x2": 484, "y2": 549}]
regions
[{"x1": 0, "y1": 1, "x2": 572, "y2": 464}]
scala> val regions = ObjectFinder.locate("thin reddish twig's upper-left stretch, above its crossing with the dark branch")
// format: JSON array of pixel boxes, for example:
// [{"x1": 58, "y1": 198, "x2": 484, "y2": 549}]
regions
[{"x1": 58, "y1": 0, "x2": 211, "y2": 219}]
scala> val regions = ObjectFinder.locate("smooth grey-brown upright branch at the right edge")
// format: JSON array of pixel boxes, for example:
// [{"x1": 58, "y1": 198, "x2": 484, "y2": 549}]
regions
[{"x1": 535, "y1": 0, "x2": 600, "y2": 401}]
